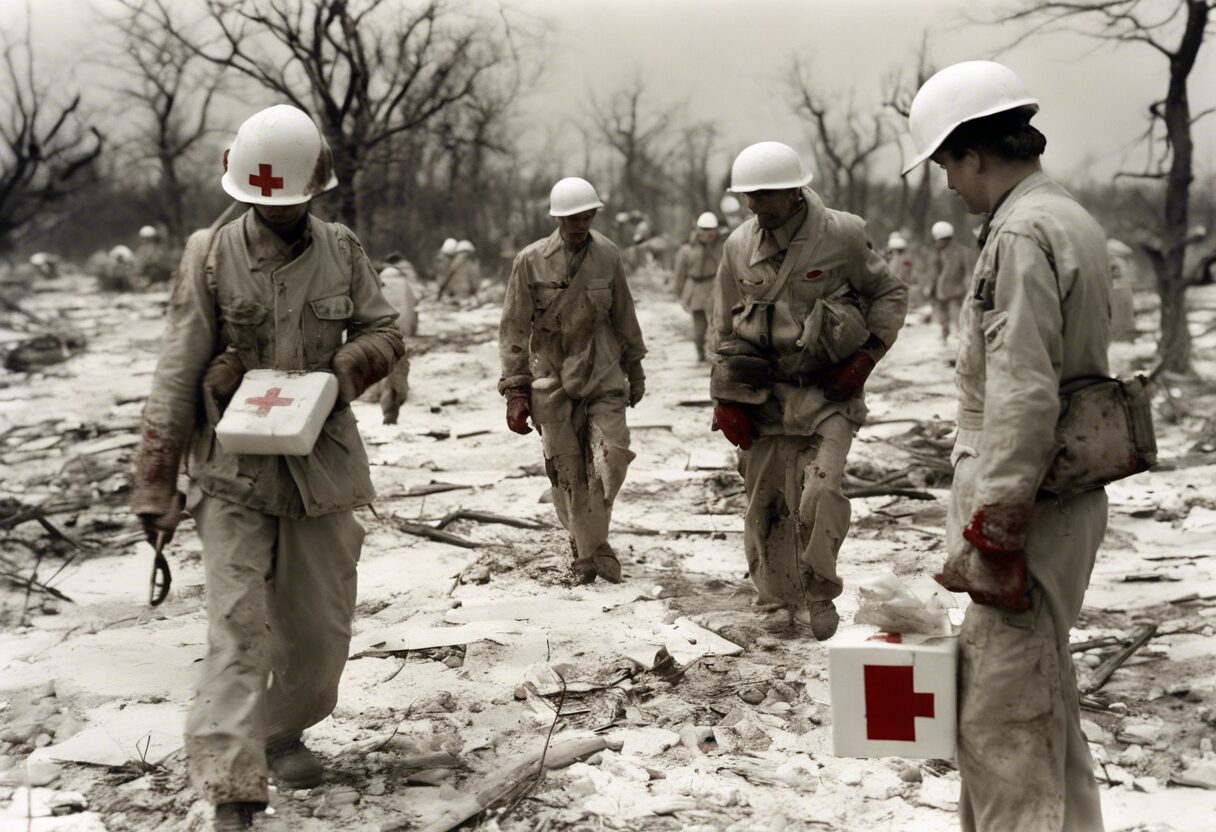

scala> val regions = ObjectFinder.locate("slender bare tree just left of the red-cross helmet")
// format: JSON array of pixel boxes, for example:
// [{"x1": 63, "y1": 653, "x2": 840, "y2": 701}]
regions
[{"x1": 113, "y1": 0, "x2": 223, "y2": 242}]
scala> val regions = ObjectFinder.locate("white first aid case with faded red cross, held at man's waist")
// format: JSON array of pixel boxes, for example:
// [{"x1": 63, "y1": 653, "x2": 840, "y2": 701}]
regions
[{"x1": 215, "y1": 370, "x2": 338, "y2": 456}]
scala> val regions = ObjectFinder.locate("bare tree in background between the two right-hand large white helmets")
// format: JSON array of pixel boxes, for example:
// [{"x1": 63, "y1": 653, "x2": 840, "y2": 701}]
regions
[{"x1": 786, "y1": 56, "x2": 888, "y2": 214}]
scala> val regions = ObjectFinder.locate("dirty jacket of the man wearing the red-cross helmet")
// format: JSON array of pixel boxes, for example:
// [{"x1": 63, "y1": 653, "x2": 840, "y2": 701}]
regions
[{"x1": 135, "y1": 208, "x2": 405, "y2": 518}]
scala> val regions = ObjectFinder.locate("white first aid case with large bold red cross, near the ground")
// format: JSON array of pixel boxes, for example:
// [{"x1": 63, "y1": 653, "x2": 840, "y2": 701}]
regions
[{"x1": 828, "y1": 628, "x2": 958, "y2": 760}]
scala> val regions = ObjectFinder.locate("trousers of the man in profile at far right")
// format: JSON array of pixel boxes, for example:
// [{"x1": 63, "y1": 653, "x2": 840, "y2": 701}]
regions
[{"x1": 947, "y1": 457, "x2": 1107, "y2": 832}]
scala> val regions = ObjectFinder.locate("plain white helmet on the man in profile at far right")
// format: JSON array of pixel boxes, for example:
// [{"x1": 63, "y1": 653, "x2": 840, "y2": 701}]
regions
[{"x1": 903, "y1": 61, "x2": 1038, "y2": 174}]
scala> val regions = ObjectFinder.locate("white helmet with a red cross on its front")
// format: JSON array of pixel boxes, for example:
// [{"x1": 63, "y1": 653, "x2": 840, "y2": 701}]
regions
[{"x1": 220, "y1": 105, "x2": 338, "y2": 206}]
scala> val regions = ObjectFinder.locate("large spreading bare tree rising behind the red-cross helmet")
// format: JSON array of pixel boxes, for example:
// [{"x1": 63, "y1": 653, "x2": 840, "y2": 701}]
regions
[{"x1": 120, "y1": 0, "x2": 513, "y2": 233}]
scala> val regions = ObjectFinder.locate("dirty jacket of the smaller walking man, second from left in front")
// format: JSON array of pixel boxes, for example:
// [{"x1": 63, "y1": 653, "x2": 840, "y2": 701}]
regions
[{"x1": 499, "y1": 231, "x2": 646, "y2": 399}]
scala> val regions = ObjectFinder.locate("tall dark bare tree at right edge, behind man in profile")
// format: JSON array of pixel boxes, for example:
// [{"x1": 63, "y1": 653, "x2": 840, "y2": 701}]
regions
[{"x1": 995, "y1": 0, "x2": 1216, "y2": 372}]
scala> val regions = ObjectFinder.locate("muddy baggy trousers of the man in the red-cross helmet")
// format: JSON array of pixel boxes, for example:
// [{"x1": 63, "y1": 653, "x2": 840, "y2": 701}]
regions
[{"x1": 179, "y1": 495, "x2": 364, "y2": 803}]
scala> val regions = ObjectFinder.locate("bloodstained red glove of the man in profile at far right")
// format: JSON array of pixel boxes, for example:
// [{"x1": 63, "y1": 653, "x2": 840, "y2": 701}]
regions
[{"x1": 936, "y1": 505, "x2": 1031, "y2": 609}]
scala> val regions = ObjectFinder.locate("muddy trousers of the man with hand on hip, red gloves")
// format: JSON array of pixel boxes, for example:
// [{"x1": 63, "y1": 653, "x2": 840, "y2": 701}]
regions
[{"x1": 739, "y1": 414, "x2": 855, "y2": 607}]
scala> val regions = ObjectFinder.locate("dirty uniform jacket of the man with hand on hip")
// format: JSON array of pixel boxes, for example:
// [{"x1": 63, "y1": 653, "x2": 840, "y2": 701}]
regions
[{"x1": 713, "y1": 187, "x2": 908, "y2": 435}]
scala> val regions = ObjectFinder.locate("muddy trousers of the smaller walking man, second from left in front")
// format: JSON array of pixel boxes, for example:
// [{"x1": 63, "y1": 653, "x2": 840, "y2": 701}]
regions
[{"x1": 540, "y1": 397, "x2": 635, "y2": 563}]
